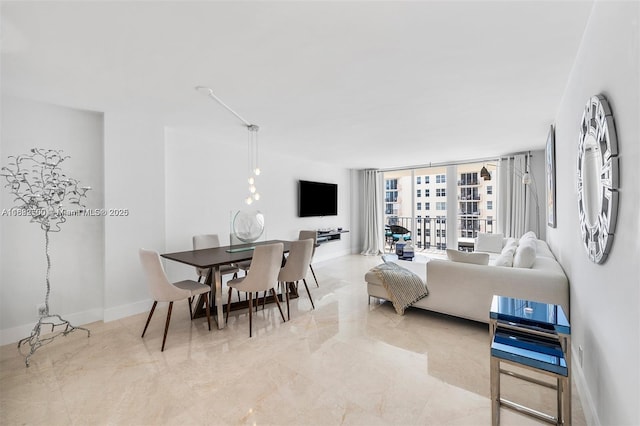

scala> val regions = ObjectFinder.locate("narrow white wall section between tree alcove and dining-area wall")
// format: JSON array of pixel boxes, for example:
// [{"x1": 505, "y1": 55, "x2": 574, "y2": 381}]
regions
[{"x1": 104, "y1": 110, "x2": 165, "y2": 321}]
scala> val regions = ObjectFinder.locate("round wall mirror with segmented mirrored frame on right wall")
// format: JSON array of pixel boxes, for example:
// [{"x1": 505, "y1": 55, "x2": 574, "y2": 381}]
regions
[{"x1": 577, "y1": 95, "x2": 619, "y2": 263}]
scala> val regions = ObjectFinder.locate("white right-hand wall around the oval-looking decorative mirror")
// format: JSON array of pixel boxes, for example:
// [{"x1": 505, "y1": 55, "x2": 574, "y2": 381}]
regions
[{"x1": 547, "y1": 2, "x2": 640, "y2": 425}]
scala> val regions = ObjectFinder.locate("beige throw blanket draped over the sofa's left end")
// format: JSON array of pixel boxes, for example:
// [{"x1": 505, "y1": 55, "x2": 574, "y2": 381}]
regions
[{"x1": 372, "y1": 262, "x2": 429, "y2": 315}]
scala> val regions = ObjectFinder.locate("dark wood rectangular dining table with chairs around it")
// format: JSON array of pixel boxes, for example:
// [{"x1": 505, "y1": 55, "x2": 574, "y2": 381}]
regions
[{"x1": 161, "y1": 240, "x2": 291, "y2": 329}]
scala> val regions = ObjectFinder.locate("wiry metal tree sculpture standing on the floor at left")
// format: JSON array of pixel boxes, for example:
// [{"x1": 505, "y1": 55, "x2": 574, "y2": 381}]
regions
[{"x1": 0, "y1": 148, "x2": 91, "y2": 367}]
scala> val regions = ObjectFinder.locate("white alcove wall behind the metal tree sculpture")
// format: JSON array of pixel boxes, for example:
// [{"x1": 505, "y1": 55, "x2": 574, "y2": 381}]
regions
[{"x1": 0, "y1": 95, "x2": 104, "y2": 343}]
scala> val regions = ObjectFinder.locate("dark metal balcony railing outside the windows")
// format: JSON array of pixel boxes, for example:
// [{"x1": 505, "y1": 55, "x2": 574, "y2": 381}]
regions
[{"x1": 387, "y1": 216, "x2": 495, "y2": 250}]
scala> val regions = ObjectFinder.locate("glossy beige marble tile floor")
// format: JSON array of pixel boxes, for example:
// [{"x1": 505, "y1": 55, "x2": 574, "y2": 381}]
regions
[{"x1": 0, "y1": 255, "x2": 585, "y2": 425}]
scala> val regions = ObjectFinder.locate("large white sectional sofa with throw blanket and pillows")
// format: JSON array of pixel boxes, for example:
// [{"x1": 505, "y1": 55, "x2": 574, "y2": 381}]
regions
[{"x1": 365, "y1": 239, "x2": 570, "y2": 323}]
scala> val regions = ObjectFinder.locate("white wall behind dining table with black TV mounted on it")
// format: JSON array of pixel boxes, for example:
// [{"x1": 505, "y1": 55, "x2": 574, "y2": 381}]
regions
[{"x1": 165, "y1": 126, "x2": 352, "y2": 279}]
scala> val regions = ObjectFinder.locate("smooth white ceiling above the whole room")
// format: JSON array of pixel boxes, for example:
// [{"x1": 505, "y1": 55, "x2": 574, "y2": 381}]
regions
[{"x1": 1, "y1": 0, "x2": 592, "y2": 168}]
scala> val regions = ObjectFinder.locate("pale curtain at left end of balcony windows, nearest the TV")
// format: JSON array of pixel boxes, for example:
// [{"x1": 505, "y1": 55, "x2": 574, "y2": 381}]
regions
[{"x1": 361, "y1": 170, "x2": 384, "y2": 256}]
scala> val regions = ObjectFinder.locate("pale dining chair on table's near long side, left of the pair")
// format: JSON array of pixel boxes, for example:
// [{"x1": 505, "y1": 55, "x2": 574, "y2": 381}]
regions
[{"x1": 225, "y1": 243, "x2": 285, "y2": 337}]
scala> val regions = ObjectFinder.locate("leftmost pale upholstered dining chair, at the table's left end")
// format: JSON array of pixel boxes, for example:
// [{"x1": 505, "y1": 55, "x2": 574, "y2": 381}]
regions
[{"x1": 139, "y1": 249, "x2": 211, "y2": 352}]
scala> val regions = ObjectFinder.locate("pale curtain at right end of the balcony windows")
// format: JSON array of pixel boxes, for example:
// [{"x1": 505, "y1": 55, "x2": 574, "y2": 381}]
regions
[{"x1": 498, "y1": 155, "x2": 529, "y2": 238}]
